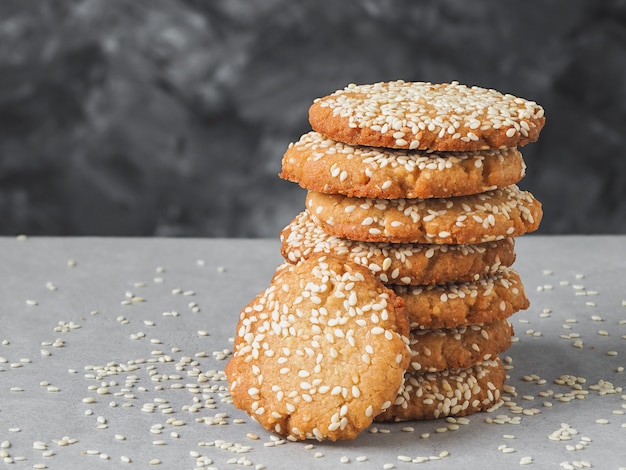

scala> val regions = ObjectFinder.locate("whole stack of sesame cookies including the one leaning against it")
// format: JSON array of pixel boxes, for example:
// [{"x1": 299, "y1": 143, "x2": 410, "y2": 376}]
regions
[{"x1": 227, "y1": 81, "x2": 545, "y2": 439}]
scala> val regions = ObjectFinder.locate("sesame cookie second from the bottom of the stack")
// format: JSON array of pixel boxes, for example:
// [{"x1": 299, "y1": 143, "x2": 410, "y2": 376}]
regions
[{"x1": 409, "y1": 319, "x2": 513, "y2": 372}]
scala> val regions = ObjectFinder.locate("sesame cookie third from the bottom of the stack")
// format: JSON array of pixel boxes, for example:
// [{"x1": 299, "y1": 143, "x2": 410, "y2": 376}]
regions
[{"x1": 390, "y1": 267, "x2": 530, "y2": 329}]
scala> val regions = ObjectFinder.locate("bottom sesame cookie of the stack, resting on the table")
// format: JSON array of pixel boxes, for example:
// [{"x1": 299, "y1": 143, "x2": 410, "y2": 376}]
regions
[{"x1": 376, "y1": 358, "x2": 506, "y2": 422}]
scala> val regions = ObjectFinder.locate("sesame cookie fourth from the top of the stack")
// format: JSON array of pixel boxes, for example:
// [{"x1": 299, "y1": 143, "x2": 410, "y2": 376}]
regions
[{"x1": 280, "y1": 211, "x2": 515, "y2": 285}]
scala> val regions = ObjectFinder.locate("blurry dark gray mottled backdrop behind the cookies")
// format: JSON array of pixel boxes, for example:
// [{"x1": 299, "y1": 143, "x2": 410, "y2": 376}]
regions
[{"x1": 0, "y1": 0, "x2": 626, "y2": 237}]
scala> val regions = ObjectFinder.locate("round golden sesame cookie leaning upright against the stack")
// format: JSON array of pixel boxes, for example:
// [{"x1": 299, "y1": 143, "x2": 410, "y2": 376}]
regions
[{"x1": 225, "y1": 256, "x2": 410, "y2": 440}]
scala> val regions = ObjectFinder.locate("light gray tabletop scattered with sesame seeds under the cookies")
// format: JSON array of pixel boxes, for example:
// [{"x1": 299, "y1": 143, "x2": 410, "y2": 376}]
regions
[{"x1": 0, "y1": 235, "x2": 626, "y2": 469}]
